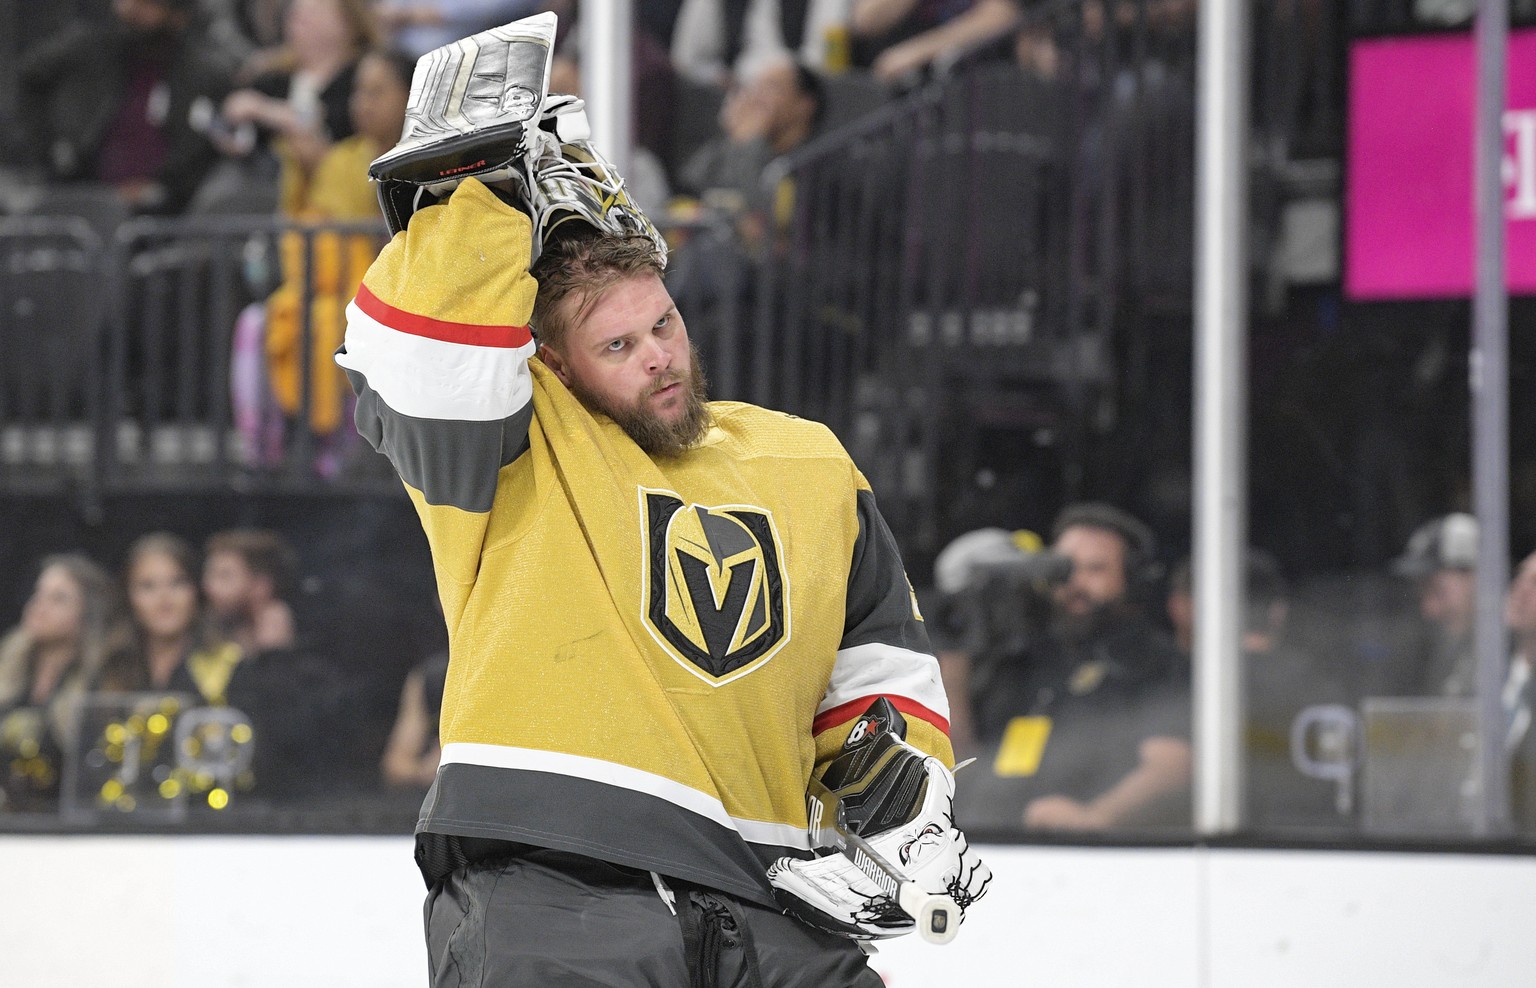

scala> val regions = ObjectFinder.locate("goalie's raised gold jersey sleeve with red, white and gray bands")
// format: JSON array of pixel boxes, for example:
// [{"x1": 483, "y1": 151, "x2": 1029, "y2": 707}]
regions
[{"x1": 336, "y1": 178, "x2": 538, "y2": 611}]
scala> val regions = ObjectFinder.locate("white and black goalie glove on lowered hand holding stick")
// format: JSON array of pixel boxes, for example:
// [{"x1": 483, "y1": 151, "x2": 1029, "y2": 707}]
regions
[{"x1": 768, "y1": 698, "x2": 992, "y2": 940}]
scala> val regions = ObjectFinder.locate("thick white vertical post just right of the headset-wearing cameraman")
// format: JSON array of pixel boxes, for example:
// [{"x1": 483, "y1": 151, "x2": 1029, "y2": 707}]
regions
[{"x1": 1192, "y1": 0, "x2": 1249, "y2": 836}]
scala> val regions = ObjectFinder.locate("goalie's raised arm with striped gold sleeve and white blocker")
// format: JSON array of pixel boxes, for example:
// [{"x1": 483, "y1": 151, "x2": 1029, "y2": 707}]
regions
[{"x1": 336, "y1": 17, "x2": 554, "y2": 513}]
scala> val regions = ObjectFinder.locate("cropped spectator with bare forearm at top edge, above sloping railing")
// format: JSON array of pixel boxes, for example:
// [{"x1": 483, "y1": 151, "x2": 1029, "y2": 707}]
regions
[{"x1": 849, "y1": 0, "x2": 1021, "y2": 83}]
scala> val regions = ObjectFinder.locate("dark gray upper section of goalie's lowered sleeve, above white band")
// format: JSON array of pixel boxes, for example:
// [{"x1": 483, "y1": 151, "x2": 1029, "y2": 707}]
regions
[{"x1": 839, "y1": 490, "x2": 931, "y2": 653}]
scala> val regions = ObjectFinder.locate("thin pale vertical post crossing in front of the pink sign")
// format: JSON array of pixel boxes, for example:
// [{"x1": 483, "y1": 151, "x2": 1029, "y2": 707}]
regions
[{"x1": 1470, "y1": 0, "x2": 1510, "y2": 836}]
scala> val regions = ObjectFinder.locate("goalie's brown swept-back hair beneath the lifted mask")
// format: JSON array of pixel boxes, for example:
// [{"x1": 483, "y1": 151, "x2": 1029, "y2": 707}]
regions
[{"x1": 531, "y1": 227, "x2": 664, "y2": 353}]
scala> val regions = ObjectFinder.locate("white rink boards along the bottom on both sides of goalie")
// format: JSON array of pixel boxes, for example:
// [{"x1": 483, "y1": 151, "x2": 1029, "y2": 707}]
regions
[{"x1": 0, "y1": 836, "x2": 1536, "y2": 988}]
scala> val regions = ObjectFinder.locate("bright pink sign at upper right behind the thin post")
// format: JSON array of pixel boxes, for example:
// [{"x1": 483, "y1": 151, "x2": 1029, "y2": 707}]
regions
[{"x1": 1344, "y1": 31, "x2": 1536, "y2": 298}]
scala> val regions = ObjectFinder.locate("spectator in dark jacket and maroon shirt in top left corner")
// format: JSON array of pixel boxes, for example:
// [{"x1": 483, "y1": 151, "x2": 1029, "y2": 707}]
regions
[{"x1": 17, "y1": 0, "x2": 229, "y2": 214}]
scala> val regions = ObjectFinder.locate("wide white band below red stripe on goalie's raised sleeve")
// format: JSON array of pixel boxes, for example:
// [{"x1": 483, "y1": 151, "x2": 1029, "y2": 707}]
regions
[{"x1": 336, "y1": 303, "x2": 535, "y2": 423}]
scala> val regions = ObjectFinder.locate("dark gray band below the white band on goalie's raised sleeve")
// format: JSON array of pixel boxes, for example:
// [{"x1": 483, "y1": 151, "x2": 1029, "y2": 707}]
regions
[{"x1": 347, "y1": 370, "x2": 533, "y2": 512}]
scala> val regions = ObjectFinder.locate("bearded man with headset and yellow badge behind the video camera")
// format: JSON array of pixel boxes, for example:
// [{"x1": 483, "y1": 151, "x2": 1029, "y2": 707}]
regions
[{"x1": 955, "y1": 502, "x2": 1190, "y2": 830}]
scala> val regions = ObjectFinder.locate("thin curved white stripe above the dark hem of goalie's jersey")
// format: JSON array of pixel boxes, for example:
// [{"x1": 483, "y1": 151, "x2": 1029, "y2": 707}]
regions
[{"x1": 439, "y1": 741, "x2": 811, "y2": 850}]
